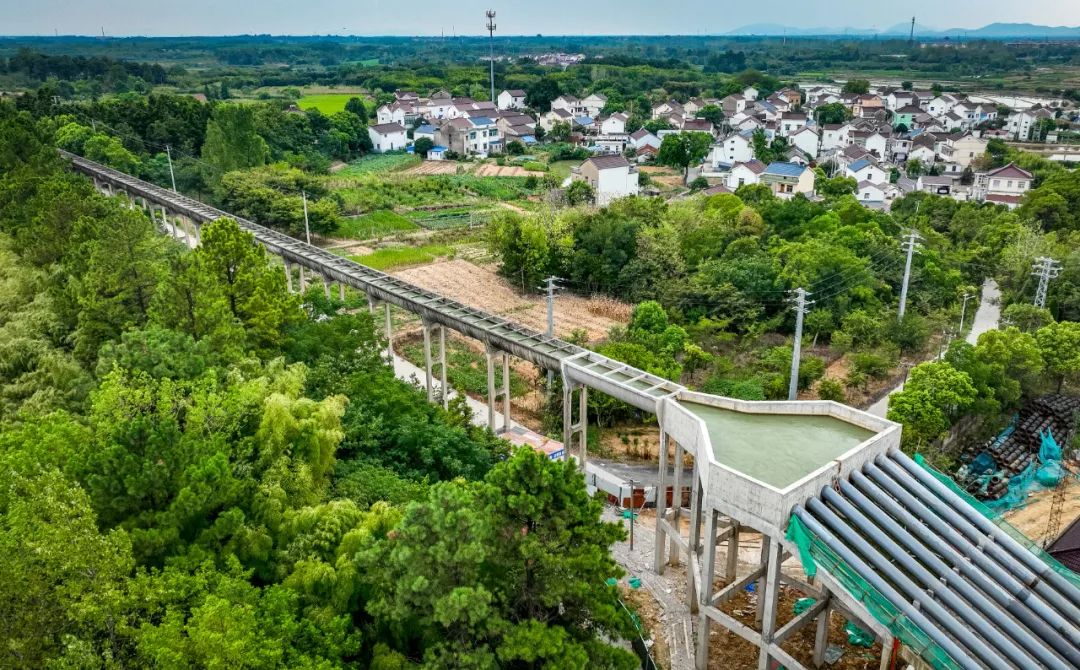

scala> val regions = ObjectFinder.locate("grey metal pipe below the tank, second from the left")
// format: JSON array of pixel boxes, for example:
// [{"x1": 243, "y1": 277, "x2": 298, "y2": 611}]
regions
[{"x1": 807, "y1": 498, "x2": 1012, "y2": 670}]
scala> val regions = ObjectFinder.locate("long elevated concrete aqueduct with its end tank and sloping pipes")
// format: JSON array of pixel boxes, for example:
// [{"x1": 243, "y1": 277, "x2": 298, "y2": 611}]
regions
[{"x1": 64, "y1": 153, "x2": 1080, "y2": 670}]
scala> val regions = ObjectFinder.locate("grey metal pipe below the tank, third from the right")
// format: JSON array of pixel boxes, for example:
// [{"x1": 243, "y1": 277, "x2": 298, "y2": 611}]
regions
[{"x1": 840, "y1": 472, "x2": 1078, "y2": 667}]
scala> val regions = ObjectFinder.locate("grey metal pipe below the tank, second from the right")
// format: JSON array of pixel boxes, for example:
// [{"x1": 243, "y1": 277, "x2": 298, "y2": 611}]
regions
[{"x1": 852, "y1": 466, "x2": 1077, "y2": 653}]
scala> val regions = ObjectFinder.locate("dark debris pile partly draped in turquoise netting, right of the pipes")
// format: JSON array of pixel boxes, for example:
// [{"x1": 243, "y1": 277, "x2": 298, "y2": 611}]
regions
[{"x1": 956, "y1": 394, "x2": 1080, "y2": 513}]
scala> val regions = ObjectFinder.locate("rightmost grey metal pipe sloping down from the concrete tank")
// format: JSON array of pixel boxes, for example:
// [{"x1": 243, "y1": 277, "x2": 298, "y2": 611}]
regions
[{"x1": 877, "y1": 456, "x2": 1080, "y2": 626}]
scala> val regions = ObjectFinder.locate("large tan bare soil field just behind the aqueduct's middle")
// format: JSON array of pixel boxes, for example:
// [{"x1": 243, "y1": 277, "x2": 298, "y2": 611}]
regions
[{"x1": 394, "y1": 259, "x2": 633, "y2": 341}]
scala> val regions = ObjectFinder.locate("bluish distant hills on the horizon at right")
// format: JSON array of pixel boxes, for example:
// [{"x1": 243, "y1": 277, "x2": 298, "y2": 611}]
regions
[{"x1": 728, "y1": 23, "x2": 1080, "y2": 40}]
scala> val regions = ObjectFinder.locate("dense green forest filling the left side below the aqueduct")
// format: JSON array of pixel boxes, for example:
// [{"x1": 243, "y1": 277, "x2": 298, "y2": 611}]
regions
[{"x1": 0, "y1": 104, "x2": 638, "y2": 670}]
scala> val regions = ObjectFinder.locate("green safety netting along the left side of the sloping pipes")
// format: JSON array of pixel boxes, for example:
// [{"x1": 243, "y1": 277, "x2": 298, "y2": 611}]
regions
[{"x1": 787, "y1": 517, "x2": 960, "y2": 670}]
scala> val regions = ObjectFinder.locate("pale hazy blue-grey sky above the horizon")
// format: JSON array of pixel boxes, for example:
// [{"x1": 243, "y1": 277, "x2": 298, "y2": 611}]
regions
[{"x1": 0, "y1": 0, "x2": 1080, "y2": 36}]
